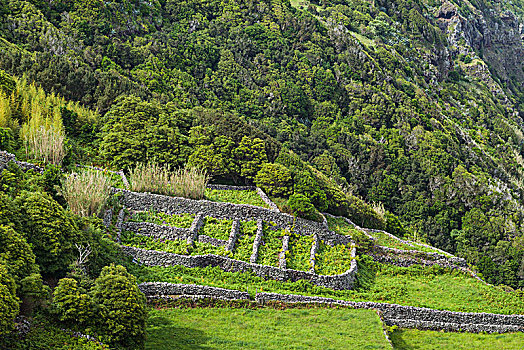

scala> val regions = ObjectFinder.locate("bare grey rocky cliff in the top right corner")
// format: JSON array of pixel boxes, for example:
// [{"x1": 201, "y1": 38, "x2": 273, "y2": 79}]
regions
[{"x1": 435, "y1": 1, "x2": 524, "y2": 104}]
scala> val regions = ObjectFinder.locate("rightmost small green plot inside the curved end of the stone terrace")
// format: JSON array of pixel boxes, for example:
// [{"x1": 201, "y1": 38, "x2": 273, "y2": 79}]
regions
[{"x1": 315, "y1": 242, "x2": 352, "y2": 275}]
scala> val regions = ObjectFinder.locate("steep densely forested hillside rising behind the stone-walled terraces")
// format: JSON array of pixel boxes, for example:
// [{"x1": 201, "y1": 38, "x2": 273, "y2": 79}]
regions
[{"x1": 0, "y1": 0, "x2": 524, "y2": 288}]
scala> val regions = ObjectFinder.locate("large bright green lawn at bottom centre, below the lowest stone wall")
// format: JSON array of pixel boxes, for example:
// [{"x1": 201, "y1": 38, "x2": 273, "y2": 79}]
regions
[{"x1": 146, "y1": 308, "x2": 391, "y2": 350}]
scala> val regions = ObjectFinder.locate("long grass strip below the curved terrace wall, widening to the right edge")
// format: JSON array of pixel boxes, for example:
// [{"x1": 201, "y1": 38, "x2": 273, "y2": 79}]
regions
[{"x1": 129, "y1": 262, "x2": 524, "y2": 314}]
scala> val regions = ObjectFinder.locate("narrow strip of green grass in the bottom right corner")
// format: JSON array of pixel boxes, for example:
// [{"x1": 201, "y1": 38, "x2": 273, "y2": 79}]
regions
[{"x1": 390, "y1": 329, "x2": 524, "y2": 350}]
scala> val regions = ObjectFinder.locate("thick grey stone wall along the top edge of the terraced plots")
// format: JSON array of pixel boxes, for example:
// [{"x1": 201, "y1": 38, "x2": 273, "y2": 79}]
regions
[{"x1": 114, "y1": 189, "x2": 326, "y2": 235}]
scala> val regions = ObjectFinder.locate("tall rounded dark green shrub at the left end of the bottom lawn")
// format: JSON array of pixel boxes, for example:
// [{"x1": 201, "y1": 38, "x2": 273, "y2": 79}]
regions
[{"x1": 92, "y1": 264, "x2": 147, "y2": 349}]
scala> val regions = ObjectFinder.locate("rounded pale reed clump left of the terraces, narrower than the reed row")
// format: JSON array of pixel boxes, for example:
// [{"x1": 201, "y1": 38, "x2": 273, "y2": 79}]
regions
[{"x1": 61, "y1": 170, "x2": 111, "y2": 216}]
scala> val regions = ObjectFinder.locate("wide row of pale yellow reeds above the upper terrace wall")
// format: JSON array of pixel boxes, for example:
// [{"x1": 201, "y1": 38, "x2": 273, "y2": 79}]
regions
[{"x1": 129, "y1": 162, "x2": 209, "y2": 199}]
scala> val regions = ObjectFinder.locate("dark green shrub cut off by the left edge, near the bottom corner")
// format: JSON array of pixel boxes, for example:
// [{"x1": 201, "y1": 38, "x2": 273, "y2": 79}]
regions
[{"x1": 0, "y1": 264, "x2": 19, "y2": 338}]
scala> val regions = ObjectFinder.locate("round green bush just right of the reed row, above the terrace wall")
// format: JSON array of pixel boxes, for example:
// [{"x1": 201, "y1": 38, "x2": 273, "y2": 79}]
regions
[{"x1": 255, "y1": 163, "x2": 293, "y2": 197}]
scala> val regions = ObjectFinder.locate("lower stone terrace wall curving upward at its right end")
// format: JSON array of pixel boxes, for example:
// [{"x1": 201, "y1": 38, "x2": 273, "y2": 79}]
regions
[{"x1": 122, "y1": 246, "x2": 358, "y2": 290}]
